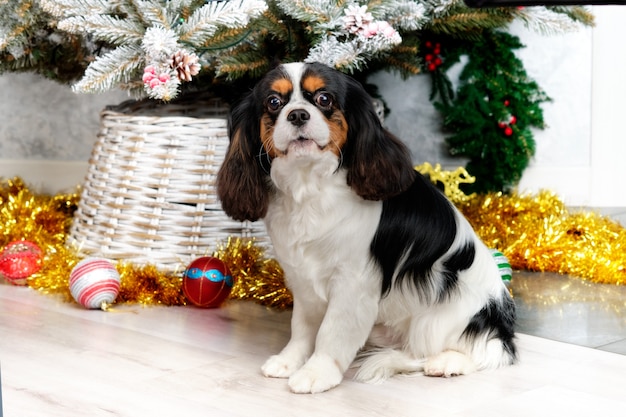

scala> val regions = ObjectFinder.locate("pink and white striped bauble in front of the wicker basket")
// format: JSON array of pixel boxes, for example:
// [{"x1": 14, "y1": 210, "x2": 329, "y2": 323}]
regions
[{"x1": 70, "y1": 258, "x2": 120, "y2": 310}]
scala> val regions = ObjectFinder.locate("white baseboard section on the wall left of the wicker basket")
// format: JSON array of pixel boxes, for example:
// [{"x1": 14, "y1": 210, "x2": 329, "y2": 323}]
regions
[{"x1": 0, "y1": 159, "x2": 89, "y2": 194}]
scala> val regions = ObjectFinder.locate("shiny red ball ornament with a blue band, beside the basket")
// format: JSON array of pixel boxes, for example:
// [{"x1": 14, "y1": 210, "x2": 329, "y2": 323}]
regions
[{"x1": 183, "y1": 256, "x2": 233, "y2": 308}]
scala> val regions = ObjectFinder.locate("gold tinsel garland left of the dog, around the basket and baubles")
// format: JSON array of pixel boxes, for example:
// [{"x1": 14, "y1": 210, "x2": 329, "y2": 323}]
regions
[{"x1": 0, "y1": 178, "x2": 292, "y2": 308}]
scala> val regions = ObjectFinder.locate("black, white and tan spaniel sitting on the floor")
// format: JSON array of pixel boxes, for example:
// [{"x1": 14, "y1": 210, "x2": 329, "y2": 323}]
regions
[{"x1": 217, "y1": 62, "x2": 517, "y2": 393}]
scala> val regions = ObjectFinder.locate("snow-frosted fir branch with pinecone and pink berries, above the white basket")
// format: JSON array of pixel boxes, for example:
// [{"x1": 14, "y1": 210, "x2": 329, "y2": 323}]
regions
[{"x1": 42, "y1": 0, "x2": 267, "y2": 101}]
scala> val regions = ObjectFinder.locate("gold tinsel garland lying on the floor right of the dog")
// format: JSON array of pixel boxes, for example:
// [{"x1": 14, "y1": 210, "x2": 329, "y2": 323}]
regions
[{"x1": 459, "y1": 191, "x2": 626, "y2": 285}]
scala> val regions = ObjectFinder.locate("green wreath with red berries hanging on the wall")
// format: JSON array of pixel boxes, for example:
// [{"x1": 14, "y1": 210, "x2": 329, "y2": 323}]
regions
[{"x1": 421, "y1": 30, "x2": 550, "y2": 192}]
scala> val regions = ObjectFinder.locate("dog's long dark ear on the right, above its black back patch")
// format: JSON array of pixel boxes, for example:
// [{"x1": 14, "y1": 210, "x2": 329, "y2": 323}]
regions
[{"x1": 344, "y1": 77, "x2": 415, "y2": 200}]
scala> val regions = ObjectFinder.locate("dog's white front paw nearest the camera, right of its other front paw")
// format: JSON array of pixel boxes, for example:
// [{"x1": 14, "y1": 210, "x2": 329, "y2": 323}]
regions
[{"x1": 289, "y1": 358, "x2": 343, "y2": 394}]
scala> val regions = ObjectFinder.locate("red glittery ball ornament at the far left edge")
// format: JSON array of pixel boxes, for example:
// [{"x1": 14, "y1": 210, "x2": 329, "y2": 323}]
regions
[{"x1": 0, "y1": 240, "x2": 42, "y2": 285}]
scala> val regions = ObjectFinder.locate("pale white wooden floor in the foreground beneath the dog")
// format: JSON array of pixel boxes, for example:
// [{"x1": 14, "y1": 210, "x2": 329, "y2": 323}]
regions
[{"x1": 0, "y1": 283, "x2": 626, "y2": 417}]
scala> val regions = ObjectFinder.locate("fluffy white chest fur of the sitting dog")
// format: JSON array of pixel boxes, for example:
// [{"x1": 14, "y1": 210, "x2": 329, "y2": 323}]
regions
[{"x1": 265, "y1": 153, "x2": 382, "y2": 299}]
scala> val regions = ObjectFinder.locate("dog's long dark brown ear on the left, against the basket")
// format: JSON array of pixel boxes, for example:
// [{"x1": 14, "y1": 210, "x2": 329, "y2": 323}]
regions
[{"x1": 217, "y1": 93, "x2": 269, "y2": 221}]
